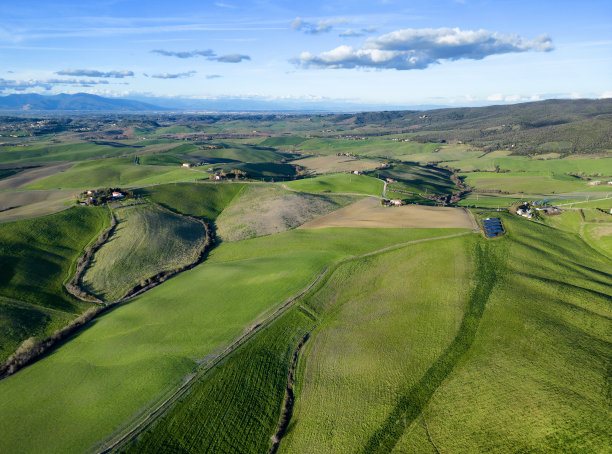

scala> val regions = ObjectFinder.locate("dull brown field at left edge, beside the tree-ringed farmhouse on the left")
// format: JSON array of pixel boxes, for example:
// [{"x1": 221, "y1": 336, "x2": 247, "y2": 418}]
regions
[{"x1": 0, "y1": 189, "x2": 78, "y2": 222}]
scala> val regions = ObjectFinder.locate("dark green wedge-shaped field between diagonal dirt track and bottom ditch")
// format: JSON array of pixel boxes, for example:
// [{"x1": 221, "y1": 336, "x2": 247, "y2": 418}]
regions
[{"x1": 126, "y1": 308, "x2": 314, "y2": 453}]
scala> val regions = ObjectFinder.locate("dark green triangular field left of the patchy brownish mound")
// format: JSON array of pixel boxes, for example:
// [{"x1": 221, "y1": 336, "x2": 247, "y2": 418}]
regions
[{"x1": 138, "y1": 183, "x2": 245, "y2": 221}]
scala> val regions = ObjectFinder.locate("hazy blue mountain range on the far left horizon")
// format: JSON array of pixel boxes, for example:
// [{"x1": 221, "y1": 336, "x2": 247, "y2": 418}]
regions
[{"x1": 0, "y1": 93, "x2": 167, "y2": 112}]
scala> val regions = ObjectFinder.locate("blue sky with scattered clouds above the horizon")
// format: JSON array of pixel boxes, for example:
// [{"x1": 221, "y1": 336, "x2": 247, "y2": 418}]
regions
[{"x1": 0, "y1": 0, "x2": 612, "y2": 107}]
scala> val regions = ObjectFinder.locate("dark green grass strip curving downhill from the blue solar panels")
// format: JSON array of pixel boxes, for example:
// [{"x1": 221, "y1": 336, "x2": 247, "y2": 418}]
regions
[{"x1": 360, "y1": 244, "x2": 499, "y2": 454}]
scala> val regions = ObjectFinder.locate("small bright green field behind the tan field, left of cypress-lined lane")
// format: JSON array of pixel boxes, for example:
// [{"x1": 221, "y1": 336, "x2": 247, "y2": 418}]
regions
[{"x1": 287, "y1": 173, "x2": 384, "y2": 196}]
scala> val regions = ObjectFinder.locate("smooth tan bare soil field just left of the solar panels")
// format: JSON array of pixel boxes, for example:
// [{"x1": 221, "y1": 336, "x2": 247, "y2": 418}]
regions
[{"x1": 299, "y1": 197, "x2": 478, "y2": 229}]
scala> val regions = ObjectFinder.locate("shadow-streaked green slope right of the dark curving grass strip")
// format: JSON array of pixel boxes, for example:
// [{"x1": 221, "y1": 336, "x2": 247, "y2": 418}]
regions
[{"x1": 395, "y1": 215, "x2": 612, "y2": 453}]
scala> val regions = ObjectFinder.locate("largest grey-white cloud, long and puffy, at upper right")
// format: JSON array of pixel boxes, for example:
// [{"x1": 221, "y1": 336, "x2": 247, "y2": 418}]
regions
[{"x1": 293, "y1": 28, "x2": 553, "y2": 70}]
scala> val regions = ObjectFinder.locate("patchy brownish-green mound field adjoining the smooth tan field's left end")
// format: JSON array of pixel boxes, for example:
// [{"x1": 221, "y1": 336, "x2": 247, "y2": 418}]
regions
[{"x1": 216, "y1": 184, "x2": 355, "y2": 241}]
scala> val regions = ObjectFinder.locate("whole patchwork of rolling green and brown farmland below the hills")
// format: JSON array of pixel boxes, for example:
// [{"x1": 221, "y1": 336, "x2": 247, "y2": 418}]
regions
[{"x1": 0, "y1": 102, "x2": 612, "y2": 453}]
